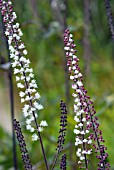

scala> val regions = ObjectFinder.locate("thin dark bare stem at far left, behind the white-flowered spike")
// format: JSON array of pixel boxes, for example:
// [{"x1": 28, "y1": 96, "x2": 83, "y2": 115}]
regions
[{"x1": 1, "y1": 15, "x2": 17, "y2": 170}]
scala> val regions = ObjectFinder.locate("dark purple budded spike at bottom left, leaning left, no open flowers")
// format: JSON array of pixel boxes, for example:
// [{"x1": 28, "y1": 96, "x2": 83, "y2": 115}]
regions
[{"x1": 14, "y1": 119, "x2": 33, "y2": 170}]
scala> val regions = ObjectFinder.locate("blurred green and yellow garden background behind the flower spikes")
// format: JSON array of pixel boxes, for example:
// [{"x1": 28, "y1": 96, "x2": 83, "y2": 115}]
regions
[{"x1": 0, "y1": 0, "x2": 114, "y2": 170}]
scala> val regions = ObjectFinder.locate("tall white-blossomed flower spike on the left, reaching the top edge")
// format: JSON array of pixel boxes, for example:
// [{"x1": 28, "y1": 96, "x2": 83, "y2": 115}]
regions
[{"x1": 1, "y1": 0, "x2": 47, "y2": 140}]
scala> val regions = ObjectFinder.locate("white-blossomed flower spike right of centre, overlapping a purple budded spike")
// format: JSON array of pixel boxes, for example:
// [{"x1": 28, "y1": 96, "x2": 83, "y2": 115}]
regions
[{"x1": 64, "y1": 30, "x2": 92, "y2": 161}]
